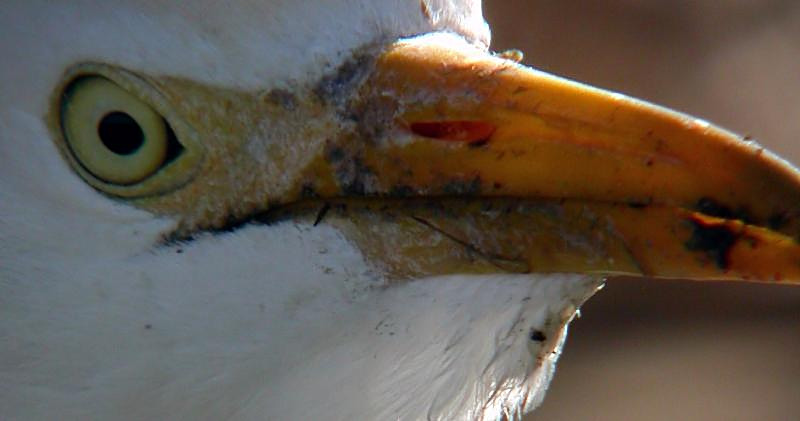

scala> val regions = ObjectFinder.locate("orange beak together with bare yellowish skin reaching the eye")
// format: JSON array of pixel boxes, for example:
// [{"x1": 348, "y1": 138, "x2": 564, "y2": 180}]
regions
[{"x1": 53, "y1": 38, "x2": 800, "y2": 282}]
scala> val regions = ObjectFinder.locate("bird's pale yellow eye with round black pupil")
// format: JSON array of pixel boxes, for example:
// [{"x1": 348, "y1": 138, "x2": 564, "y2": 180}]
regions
[{"x1": 61, "y1": 76, "x2": 181, "y2": 185}]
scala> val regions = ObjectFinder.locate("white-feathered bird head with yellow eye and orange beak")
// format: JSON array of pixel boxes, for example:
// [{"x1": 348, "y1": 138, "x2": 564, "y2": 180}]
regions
[{"x1": 0, "y1": 0, "x2": 800, "y2": 419}]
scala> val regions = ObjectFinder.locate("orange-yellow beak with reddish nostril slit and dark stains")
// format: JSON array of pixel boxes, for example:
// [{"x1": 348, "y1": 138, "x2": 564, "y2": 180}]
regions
[{"x1": 286, "y1": 38, "x2": 800, "y2": 282}]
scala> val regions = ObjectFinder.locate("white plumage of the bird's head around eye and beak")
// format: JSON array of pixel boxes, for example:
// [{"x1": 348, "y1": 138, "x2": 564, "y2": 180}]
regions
[{"x1": 0, "y1": 1, "x2": 599, "y2": 419}]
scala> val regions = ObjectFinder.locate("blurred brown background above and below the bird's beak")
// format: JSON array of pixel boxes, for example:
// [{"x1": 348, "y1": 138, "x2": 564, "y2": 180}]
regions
[{"x1": 484, "y1": 0, "x2": 800, "y2": 421}]
